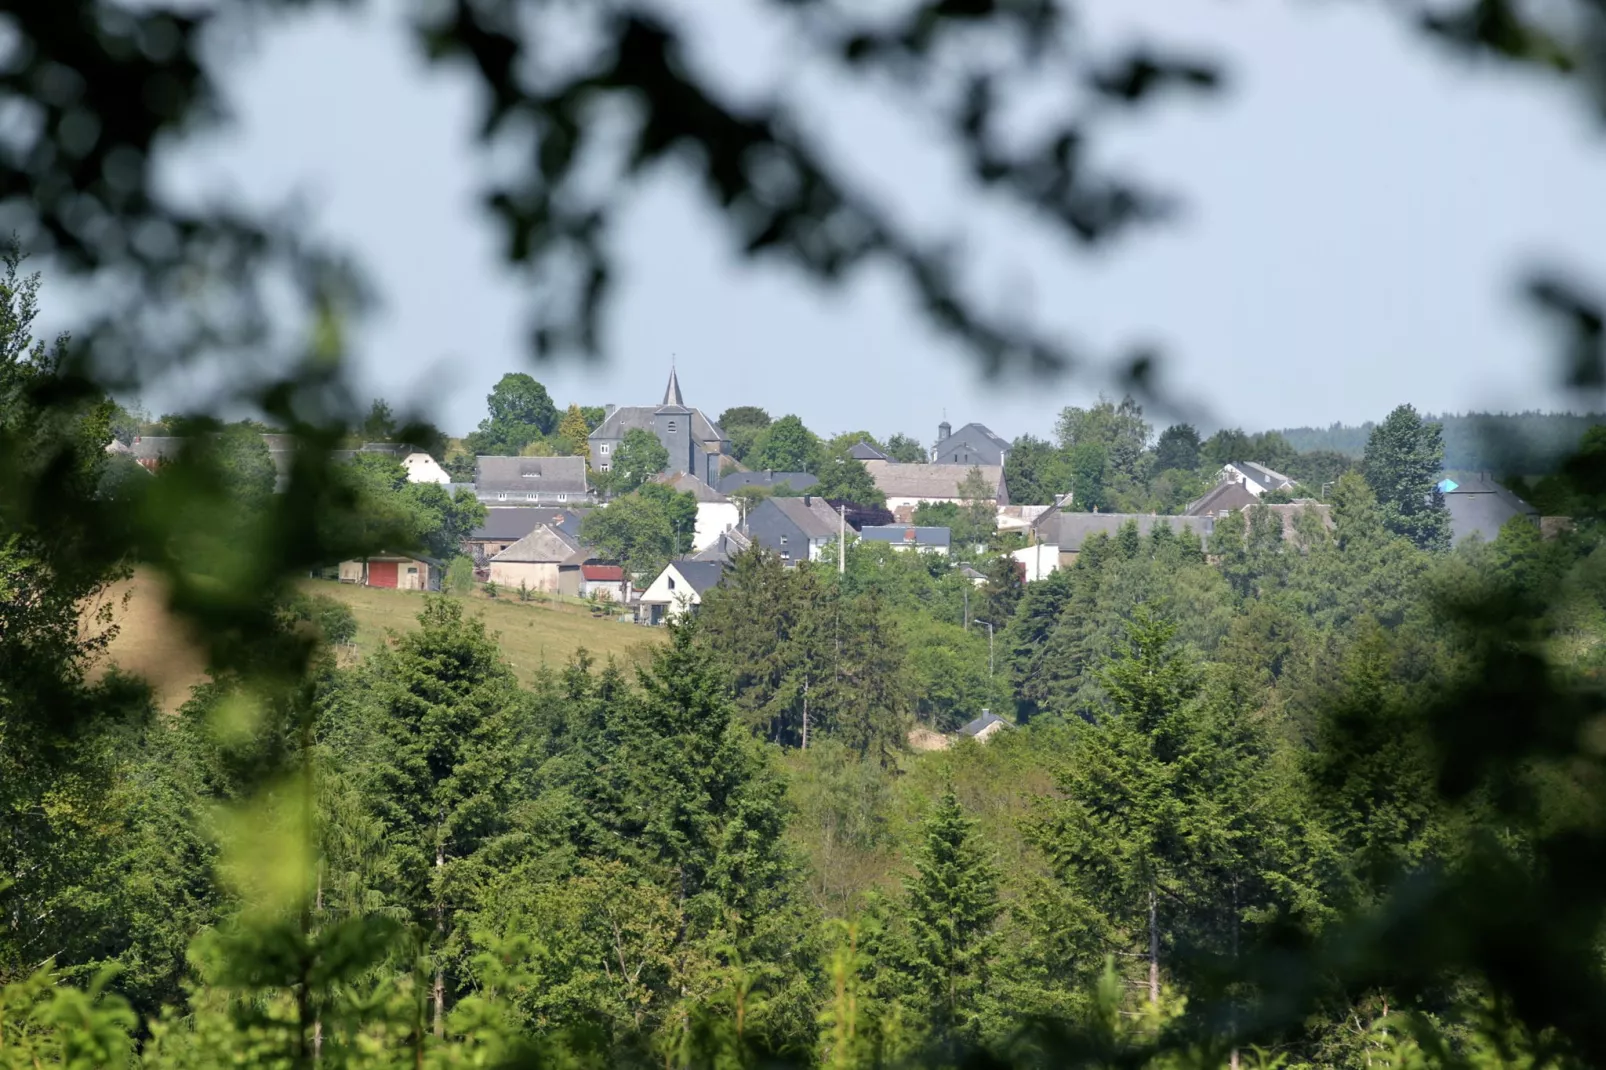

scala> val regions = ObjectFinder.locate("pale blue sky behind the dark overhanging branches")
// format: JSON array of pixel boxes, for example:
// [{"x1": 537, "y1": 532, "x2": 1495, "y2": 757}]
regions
[{"x1": 128, "y1": 0, "x2": 1606, "y2": 440}]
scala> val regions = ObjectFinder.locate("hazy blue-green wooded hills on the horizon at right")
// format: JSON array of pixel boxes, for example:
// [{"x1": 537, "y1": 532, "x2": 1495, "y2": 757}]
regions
[{"x1": 1278, "y1": 413, "x2": 1606, "y2": 476}]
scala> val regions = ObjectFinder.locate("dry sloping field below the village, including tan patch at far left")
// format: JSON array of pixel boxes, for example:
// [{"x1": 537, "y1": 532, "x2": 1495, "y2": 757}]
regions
[{"x1": 93, "y1": 574, "x2": 662, "y2": 710}]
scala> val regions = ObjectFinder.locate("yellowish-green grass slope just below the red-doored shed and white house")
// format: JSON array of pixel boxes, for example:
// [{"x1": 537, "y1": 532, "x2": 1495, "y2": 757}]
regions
[{"x1": 305, "y1": 580, "x2": 663, "y2": 683}]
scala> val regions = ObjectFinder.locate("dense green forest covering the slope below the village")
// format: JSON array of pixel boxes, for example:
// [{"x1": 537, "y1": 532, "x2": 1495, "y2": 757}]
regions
[{"x1": 9, "y1": 245, "x2": 1606, "y2": 1070}]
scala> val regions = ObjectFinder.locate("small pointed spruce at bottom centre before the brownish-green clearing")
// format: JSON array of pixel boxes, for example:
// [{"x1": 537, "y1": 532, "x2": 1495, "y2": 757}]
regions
[{"x1": 904, "y1": 787, "x2": 1001, "y2": 1048}]
